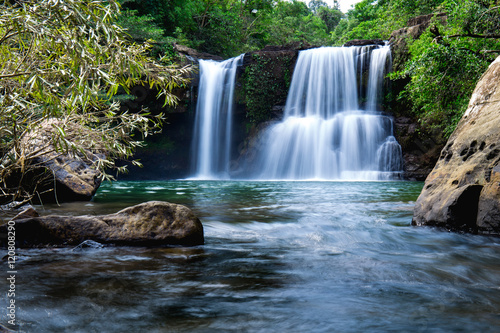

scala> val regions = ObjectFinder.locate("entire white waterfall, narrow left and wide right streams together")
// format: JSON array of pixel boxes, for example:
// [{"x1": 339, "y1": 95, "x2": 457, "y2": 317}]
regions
[{"x1": 192, "y1": 45, "x2": 403, "y2": 180}]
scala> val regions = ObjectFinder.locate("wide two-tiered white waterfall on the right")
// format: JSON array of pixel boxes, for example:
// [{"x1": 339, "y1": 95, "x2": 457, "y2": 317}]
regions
[{"x1": 256, "y1": 45, "x2": 402, "y2": 180}]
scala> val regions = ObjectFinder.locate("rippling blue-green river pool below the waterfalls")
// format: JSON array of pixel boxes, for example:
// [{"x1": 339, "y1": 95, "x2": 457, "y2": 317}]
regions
[{"x1": 0, "y1": 181, "x2": 500, "y2": 333}]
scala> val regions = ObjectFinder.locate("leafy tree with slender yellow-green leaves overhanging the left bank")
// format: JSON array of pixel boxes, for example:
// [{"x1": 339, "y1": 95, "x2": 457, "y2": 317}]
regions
[{"x1": 0, "y1": 0, "x2": 190, "y2": 200}]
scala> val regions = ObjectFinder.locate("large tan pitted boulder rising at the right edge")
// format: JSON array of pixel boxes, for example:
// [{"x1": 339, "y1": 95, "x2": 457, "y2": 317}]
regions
[{"x1": 412, "y1": 57, "x2": 500, "y2": 235}]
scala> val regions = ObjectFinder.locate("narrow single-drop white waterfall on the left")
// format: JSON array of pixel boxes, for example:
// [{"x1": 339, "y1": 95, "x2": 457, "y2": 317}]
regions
[{"x1": 192, "y1": 55, "x2": 243, "y2": 179}]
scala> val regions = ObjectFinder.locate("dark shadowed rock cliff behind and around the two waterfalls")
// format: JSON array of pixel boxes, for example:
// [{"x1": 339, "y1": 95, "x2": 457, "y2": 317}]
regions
[{"x1": 126, "y1": 31, "x2": 444, "y2": 181}]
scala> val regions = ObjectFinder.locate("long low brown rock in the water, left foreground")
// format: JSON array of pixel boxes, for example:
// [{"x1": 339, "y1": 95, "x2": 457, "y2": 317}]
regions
[{"x1": 0, "y1": 201, "x2": 204, "y2": 247}]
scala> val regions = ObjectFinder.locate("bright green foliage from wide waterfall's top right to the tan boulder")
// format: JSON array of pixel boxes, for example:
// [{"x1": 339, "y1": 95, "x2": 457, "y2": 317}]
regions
[{"x1": 331, "y1": 0, "x2": 500, "y2": 135}]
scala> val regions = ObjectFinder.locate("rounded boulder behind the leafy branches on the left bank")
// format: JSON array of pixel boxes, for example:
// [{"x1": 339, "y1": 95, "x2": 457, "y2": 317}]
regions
[{"x1": 0, "y1": 119, "x2": 104, "y2": 203}]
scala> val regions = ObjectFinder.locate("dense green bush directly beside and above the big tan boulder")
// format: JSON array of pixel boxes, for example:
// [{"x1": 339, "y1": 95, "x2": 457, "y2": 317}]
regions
[{"x1": 393, "y1": 0, "x2": 500, "y2": 136}]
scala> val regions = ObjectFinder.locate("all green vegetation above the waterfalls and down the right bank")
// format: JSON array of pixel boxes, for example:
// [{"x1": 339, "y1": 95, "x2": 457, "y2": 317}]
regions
[{"x1": 121, "y1": 0, "x2": 500, "y2": 135}]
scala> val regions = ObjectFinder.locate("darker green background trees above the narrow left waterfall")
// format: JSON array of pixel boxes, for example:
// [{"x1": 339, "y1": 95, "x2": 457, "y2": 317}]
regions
[{"x1": 121, "y1": 0, "x2": 342, "y2": 57}]
